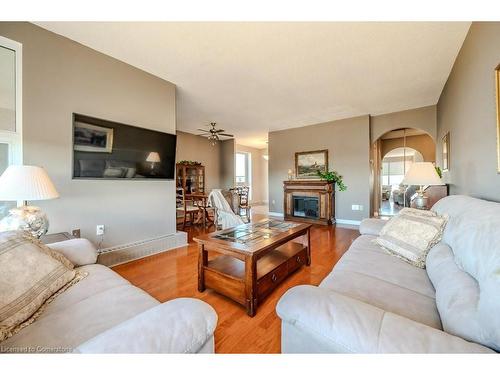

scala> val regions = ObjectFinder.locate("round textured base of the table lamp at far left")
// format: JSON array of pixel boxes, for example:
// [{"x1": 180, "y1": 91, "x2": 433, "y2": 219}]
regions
[{"x1": 0, "y1": 206, "x2": 49, "y2": 238}]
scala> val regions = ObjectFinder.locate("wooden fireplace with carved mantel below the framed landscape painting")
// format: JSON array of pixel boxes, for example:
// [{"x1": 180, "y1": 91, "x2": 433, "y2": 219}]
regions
[{"x1": 283, "y1": 179, "x2": 335, "y2": 225}]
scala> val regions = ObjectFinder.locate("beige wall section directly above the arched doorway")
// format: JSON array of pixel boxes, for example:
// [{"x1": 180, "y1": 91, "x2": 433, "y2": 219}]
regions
[{"x1": 370, "y1": 105, "x2": 436, "y2": 142}]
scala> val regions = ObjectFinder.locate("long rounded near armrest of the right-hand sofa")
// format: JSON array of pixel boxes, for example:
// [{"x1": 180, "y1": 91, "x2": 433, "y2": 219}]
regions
[{"x1": 276, "y1": 285, "x2": 491, "y2": 353}]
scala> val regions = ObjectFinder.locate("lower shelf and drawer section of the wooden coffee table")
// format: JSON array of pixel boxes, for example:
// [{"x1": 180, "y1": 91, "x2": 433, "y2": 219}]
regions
[{"x1": 203, "y1": 241, "x2": 310, "y2": 316}]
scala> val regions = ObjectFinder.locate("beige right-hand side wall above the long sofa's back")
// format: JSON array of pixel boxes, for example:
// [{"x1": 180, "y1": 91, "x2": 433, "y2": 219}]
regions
[{"x1": 436, "y1": 22, "x2": 500, "y2": 201}]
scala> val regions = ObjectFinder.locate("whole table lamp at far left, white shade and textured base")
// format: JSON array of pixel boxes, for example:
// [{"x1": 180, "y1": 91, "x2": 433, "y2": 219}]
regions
[{"x1": 0, "y1": 165, "x2": 59, "y2": 238}]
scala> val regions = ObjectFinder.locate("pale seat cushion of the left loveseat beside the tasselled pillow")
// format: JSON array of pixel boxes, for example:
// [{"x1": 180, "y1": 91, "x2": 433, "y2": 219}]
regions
[{"x1": 2, "y1": 264, "x2": 159, "y2": 351}]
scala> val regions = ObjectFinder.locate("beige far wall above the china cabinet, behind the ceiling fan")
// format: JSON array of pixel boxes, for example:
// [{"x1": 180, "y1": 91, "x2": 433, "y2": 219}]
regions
[{"x1": 175, "y1": 131, "x2": 221, "y2": 193}]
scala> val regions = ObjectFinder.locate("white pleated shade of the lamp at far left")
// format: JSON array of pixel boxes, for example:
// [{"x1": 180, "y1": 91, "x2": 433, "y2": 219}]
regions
[{"x1": 0, "y1": 165, "x2": 59, "y2": 201}]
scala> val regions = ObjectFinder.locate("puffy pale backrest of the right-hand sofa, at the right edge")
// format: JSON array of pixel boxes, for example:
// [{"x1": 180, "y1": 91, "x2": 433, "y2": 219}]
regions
[{"x1": 430, "y1": 195, "x2": 500, "y2": 351}]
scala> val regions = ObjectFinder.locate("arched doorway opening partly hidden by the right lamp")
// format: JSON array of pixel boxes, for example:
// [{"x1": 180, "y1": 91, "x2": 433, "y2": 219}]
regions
[{"x1": 372, "y1": 128, "x2": 436, "y2": 216}]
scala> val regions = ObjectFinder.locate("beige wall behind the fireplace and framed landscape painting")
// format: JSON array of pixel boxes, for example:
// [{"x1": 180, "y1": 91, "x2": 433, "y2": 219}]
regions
[{"x1": 269, "y1": 116, "x2": 370, "y2": 221}]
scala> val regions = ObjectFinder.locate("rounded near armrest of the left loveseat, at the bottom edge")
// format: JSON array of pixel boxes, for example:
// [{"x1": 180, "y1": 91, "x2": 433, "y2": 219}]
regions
[{"x1": 75, "y1": 298, "x2": 217, "y2": 353}]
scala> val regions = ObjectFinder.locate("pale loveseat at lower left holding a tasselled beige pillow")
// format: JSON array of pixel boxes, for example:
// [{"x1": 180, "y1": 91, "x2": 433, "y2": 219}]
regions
[{"x1": 0, "y1": 239, "x2": 217, "y2": 353}]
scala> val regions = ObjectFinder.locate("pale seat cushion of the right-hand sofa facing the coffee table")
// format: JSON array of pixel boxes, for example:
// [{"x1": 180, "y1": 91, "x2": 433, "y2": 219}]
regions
[{"x1": 320, "y1": 235, "x2": 441, "y2": 329}]
